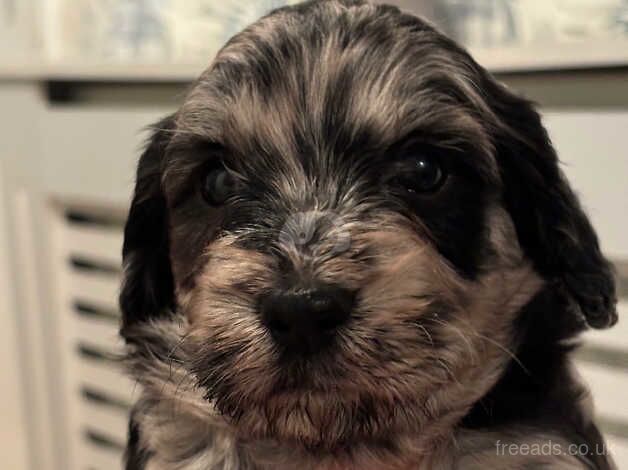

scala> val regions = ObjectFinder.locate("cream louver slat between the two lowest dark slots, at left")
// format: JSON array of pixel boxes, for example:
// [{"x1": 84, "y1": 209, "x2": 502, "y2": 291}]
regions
[{"x1": 80, "y1": 400, "x2": 129, "y2": 443}]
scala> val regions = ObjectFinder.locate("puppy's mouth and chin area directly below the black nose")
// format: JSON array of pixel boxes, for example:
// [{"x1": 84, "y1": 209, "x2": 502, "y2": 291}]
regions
[{"x1": 189, "y1": 326, "x2": 440, "y2": 450}]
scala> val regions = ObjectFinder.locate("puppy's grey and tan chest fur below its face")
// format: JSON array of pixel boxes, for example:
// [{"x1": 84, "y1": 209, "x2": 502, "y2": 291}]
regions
[{"x1": 127, "y1": 321, "x2": 595, "y2": 470}]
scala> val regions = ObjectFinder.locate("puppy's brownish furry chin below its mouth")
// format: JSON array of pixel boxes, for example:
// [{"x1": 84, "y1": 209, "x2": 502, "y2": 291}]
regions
[{"x1": 209, "y1": 372, "x2": 426, "y2": 452}]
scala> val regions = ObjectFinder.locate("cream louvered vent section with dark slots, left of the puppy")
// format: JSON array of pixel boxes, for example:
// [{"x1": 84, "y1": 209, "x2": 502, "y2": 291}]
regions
[{"x1": 49, "y1": 207, "x2": 135, "y2": 470}]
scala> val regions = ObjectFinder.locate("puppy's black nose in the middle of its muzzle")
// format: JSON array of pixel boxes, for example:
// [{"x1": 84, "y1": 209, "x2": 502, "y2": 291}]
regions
[{"x1": 260, "y1": 286, "x2": 355, "y2": 354}]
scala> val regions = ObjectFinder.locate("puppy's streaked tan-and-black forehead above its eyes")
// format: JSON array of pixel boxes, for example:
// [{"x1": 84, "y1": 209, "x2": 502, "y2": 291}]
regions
[{"x1": 177, "y1": 1, "x2": 492, "y2": 173}]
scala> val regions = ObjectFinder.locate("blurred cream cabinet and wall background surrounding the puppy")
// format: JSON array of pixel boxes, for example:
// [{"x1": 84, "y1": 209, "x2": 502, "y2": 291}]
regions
[{"x1": 0, "y1": 0, "x2": 628, "y2": 470}]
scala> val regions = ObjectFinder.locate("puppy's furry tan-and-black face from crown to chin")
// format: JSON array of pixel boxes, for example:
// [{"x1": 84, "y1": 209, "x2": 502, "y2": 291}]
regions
[{"x1": 123, "y1": 1, "x2": 612, "y2": 448}]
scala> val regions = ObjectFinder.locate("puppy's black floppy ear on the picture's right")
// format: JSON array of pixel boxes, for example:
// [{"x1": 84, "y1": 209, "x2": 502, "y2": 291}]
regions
[{"x1": 485, "y1": 77, "x2": 617, "y2": 330}]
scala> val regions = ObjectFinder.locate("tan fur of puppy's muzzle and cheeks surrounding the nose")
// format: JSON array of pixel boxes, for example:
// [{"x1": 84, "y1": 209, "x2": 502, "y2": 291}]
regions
[{"x1": 170, "y1": 205, "x2": 541, "y2": 456}]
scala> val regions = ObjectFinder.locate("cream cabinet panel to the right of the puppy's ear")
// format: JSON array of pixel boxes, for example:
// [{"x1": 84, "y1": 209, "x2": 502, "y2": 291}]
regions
[{"x1": 544, "y1": 114, "x2": 628, "y2": 470}]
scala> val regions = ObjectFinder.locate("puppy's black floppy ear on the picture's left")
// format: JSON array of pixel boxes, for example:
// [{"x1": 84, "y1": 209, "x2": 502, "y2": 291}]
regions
[{"x1": 120, "y1": 116, "x2": 174, "y2": 336}]
